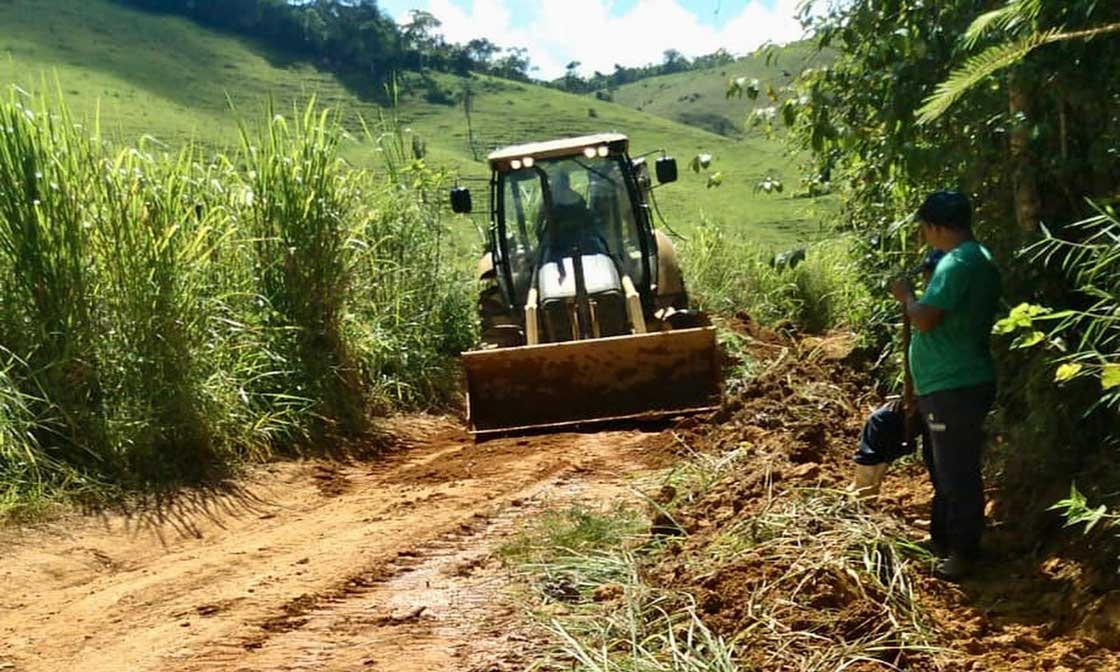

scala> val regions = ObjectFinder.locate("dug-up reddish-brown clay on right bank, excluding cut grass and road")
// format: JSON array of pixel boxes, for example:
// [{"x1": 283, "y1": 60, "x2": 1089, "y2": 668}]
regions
[{"x1": 653, "y1": 319, "x2": 1120, "y2": 672}]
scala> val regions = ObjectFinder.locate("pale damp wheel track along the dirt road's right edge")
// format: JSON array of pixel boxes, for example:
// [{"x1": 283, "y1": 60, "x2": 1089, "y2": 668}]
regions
[{"x1": 198, "y1": 474, "x2": 609, "y2": 671}]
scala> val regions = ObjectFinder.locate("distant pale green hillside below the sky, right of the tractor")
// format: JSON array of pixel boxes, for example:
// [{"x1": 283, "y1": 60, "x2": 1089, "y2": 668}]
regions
[{"x1": 613, "y1": 43, "x2": 819, "y2": 138}]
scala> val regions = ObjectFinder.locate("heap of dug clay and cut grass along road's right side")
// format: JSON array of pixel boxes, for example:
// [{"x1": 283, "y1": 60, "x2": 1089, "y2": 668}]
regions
[{"x1": 508, "y1": 319, "x2": 1120, "y2": 671}]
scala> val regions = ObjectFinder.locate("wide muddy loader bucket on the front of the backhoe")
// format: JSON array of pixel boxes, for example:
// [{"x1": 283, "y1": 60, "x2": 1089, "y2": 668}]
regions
[{"x1": 463, "y1": 327, "x2": 720, "y2": 435}]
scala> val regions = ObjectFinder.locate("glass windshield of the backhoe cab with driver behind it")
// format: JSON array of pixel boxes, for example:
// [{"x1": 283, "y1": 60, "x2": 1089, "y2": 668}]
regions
[{"x1": 497, "y1": 157, "x2": 646, "y2": 305}]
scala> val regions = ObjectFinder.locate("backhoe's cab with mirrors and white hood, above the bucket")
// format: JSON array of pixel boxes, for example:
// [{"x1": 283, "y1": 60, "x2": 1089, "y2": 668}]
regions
[{"x1": 452, "y1": 133, "x2": 676, "y2": 345}]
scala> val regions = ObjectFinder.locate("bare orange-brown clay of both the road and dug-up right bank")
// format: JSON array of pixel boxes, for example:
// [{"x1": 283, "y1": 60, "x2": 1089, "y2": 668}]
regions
[{"x1": 0, "y1": 319, "x2": 1120, "y2": 672}]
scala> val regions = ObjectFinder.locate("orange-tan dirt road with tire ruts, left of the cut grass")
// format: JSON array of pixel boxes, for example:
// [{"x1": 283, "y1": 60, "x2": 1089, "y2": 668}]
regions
[{"x1": 0, "y1": 417, "x2": 657, "y2": 672}]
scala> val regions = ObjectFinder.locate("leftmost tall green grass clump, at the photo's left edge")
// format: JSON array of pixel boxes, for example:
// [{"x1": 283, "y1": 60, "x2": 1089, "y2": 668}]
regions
[{"x1": 0, "y1": 91, "x2": 104, "y2": 468}]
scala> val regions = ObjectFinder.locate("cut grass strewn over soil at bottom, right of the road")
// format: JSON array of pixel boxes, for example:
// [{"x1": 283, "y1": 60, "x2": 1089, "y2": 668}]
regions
[{"x1": 504, "y1": 456, "x2": 945, "y2": 672}]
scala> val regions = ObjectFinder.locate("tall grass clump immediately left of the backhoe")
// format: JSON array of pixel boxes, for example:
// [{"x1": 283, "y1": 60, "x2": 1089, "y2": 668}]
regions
[{"x1": 354, "y1": 110, "x2": 478, "y2": 408}]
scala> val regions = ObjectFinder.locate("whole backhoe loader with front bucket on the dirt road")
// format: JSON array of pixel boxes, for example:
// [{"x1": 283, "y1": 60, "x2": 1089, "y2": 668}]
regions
[{"x1": 451, "y1": 133, "x2": 720, "y2": 435}]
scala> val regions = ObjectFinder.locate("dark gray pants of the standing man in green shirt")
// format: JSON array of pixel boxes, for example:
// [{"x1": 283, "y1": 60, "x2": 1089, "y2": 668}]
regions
[{"x1": 917, "y1": 383, "x2": 996, "y2": 558}]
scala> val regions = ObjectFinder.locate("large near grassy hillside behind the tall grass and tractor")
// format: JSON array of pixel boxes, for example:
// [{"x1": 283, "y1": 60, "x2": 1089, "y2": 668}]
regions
[{"x1": 0, "y1": 0, "x2": 827, "y2": 245}]
